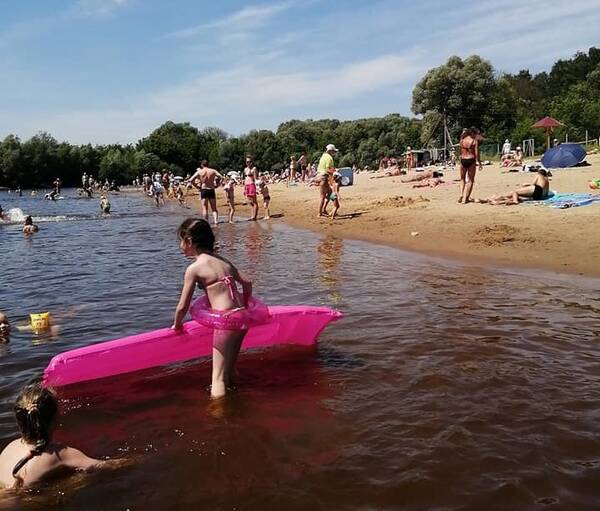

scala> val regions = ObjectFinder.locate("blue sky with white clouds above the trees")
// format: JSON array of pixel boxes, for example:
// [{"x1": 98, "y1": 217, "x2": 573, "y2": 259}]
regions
[{"x1": 0, "y1": 0, "x2": 600, "y2": 144}]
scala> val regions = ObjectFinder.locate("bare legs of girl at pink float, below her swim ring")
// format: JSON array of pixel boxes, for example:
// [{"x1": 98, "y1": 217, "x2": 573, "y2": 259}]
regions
[{"x1": 210, "y1": 330, "x2": 247, "y2": 397}]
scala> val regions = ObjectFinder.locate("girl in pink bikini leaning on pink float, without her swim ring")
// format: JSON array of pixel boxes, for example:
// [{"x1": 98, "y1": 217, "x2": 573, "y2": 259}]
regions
[{"x1": 171, "y1": 218, "x2": 252, "y2": 398}]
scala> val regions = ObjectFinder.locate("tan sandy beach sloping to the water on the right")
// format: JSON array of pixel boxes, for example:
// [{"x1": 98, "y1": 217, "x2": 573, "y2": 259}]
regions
[{"x1": 198, "y1": 154, "x2": 600, "y2": 277}]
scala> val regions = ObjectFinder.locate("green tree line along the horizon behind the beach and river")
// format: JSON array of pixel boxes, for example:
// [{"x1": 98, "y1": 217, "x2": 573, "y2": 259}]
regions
[{"x1": 0, "y1": 48, "x2": 600, "y2": 187}]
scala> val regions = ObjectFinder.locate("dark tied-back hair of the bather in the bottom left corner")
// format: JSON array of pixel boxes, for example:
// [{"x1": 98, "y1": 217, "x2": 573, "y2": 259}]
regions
[{"x1": 12, "y1": 380, "x2": 58, "y2": 478}]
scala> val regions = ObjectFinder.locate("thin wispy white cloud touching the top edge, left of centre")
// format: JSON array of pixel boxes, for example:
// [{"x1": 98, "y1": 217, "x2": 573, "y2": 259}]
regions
[{"x1": 164, "y1": 2, "x2": 292, "y2": 39}]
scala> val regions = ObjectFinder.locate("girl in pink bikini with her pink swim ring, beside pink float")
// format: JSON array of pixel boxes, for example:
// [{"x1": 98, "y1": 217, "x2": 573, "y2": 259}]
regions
[{"x1": 171, "y1": 218, "x2": 269, "y2": 398}]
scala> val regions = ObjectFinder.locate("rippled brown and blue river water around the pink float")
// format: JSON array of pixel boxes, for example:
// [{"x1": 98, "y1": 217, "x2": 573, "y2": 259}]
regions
[{"x1": 0, "y1": 192, "x2": 600, "y2": 510}]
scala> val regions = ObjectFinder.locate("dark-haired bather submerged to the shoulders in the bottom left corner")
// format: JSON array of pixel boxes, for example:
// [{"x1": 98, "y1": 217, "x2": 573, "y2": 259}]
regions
[{"x1": 0, "y1": 381, "x2": 122, "y2": 488}]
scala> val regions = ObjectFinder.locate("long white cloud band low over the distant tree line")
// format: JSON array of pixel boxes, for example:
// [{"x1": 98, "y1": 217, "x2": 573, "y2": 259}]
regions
[{"x1": 0, "y1": 55, "x2": 422, "y2": 143}]
